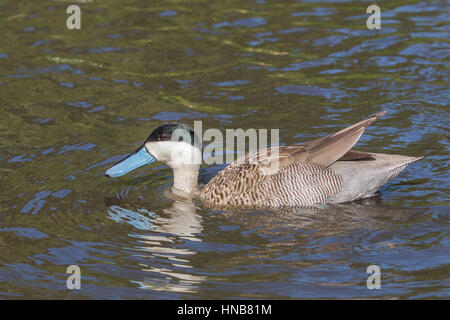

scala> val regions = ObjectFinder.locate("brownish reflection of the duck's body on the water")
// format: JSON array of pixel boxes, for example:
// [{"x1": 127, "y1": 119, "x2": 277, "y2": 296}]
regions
[{"x1": 221, "y1": 198, "x2": 425, "y2": 241}]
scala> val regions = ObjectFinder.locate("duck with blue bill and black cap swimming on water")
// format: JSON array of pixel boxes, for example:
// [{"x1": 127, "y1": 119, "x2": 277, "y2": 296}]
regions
[{"x1": 105, "y1": 111, "x2": 422, "y2": 208}]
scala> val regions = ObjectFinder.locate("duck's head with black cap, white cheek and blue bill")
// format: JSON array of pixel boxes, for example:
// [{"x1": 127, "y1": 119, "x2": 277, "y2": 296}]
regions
[{"x1": 105, "y1": 123, "x2": 202, "y2": 178}]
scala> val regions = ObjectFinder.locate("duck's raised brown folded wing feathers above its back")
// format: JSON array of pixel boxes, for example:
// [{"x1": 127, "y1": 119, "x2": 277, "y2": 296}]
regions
[{"x1": 243, "y1": 111, "x2": 386, "y2": 174}]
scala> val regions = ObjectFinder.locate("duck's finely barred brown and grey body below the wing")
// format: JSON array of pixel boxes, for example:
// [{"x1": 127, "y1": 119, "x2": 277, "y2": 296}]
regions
[{"x1": 199, "y1": 153, "x2": 419, "y2": 207}]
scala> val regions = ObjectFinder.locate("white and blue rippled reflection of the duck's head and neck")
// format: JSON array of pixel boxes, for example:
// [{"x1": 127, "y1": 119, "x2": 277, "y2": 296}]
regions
[{"x1": 108, "y1": 197, "x2": 206, "y2": 293}]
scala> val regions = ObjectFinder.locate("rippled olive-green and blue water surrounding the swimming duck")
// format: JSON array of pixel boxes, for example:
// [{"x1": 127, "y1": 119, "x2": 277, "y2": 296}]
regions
[{"x1": 0, "y1": 0, "x2": 450, "y2": 299}]
